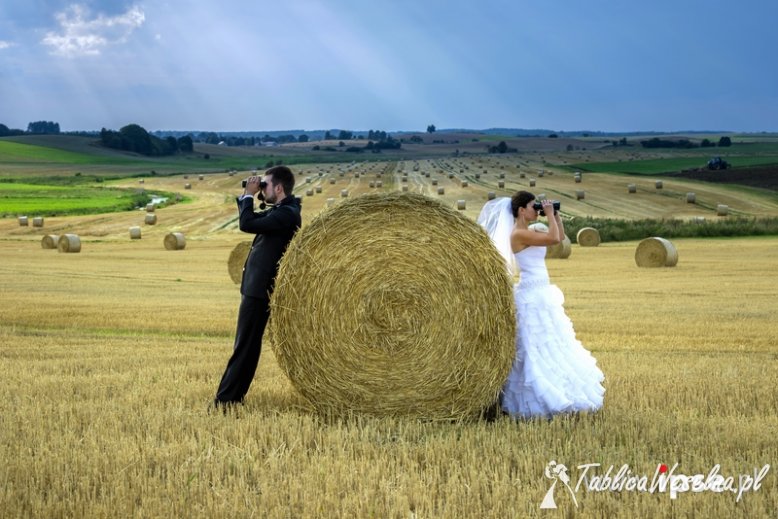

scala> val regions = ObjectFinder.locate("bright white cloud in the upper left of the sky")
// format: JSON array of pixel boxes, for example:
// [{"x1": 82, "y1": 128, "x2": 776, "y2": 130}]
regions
[{"x1": 41, "y1": 5, "x2": 146, "y2": 57}]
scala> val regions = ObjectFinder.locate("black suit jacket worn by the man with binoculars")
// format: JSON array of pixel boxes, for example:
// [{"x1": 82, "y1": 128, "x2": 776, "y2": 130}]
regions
[{"x1": 238, "y1": 195, "x2": 302, "y2": 299}]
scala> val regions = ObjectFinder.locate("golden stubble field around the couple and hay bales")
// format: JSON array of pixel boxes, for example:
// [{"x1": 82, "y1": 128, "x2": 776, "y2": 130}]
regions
[{"x1": 0, "y1": 156, "x2": 778, "y2": 517}]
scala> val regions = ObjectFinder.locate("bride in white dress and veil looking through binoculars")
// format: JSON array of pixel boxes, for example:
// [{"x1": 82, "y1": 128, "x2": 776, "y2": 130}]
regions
[{"x1": 478, "y1": 191, "x2": 605, "y2": 417}]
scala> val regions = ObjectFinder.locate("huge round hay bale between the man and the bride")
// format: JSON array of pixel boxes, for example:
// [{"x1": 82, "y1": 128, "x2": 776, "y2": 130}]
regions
[{"x1": 270, "y1": 192, "x2": 515, "y2": 419}]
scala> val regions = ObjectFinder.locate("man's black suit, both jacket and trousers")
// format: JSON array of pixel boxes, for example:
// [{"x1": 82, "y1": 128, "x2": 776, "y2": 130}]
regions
[{"x1": 215, "y1": 195, "x2": 301, "y2": 405}]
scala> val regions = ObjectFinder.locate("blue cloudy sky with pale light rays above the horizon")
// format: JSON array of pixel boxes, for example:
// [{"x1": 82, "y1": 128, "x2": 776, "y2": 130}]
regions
[{"x1": 0, "y1": 0, "x2": 778, "y2": 131}]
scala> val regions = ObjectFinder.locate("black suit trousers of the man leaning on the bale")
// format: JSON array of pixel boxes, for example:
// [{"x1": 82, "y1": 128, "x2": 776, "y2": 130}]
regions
[{"x1": 215, "y1": 296, "x2": 270, "y2": 404}]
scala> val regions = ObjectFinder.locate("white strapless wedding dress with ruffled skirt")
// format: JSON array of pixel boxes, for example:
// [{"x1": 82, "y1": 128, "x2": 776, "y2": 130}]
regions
[{"x1": 502, "y1": 246, "x2": 605, "y2": 417}]
